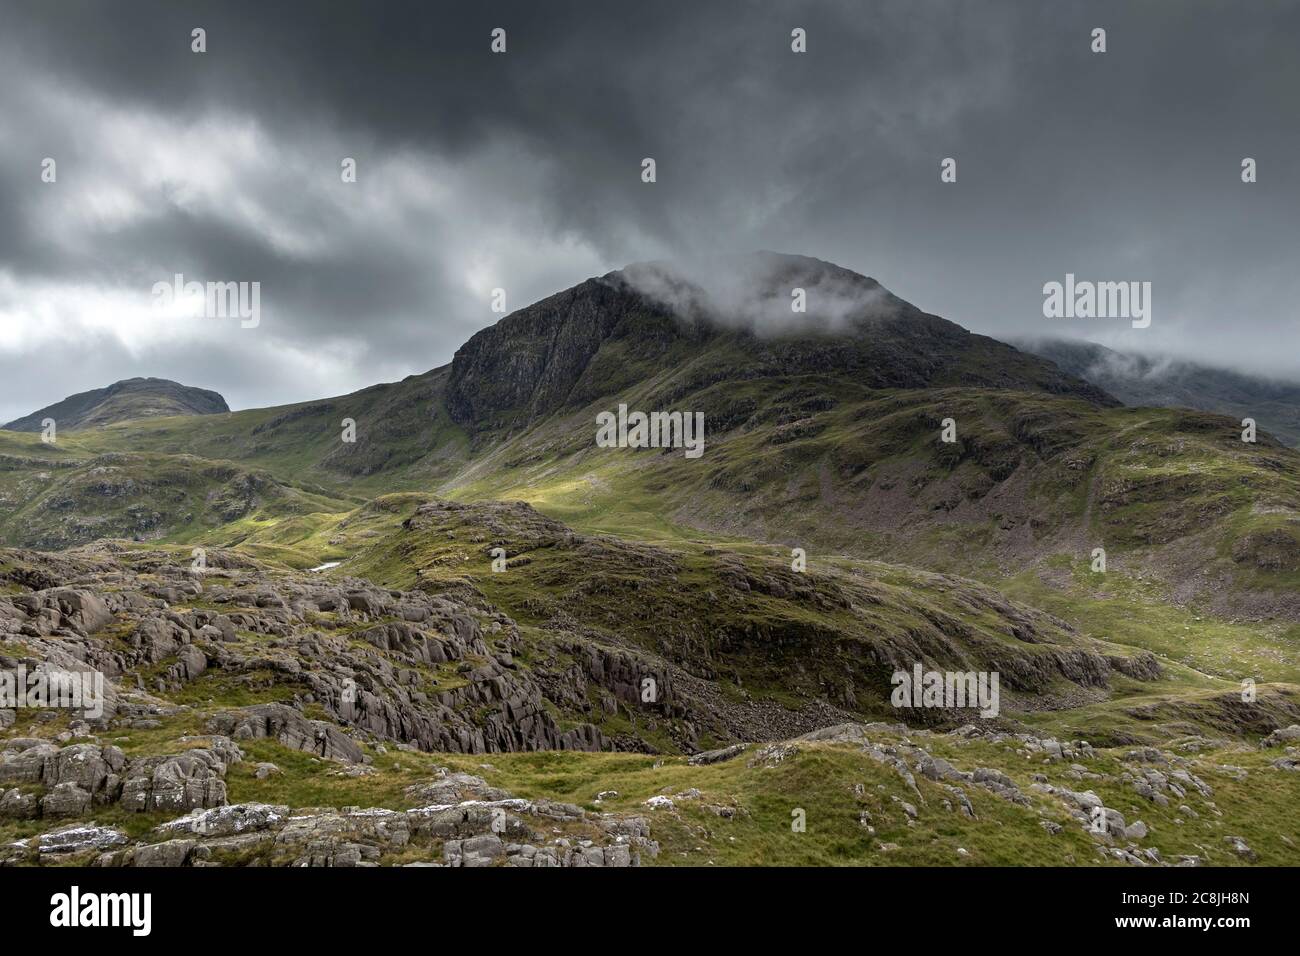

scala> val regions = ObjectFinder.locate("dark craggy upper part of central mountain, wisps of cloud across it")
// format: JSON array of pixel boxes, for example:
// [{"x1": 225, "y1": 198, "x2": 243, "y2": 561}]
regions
[{"x1": 446, "y1": 252, "x2": 1118, "y2": 432}]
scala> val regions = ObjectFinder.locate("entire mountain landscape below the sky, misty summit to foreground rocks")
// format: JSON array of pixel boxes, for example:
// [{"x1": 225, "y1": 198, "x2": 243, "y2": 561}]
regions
[{"x1": 0, "y1": 254, "x2": 1300, "y2": 865}]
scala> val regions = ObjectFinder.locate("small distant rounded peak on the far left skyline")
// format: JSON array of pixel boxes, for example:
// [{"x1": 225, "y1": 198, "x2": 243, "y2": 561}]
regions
[{"x1": 4, "y1": 378, "x2": 230, "y2": 432}]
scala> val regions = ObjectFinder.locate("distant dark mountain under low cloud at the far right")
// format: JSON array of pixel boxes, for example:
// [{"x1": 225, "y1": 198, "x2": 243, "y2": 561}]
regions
[{"x1": 1015, "y1": 338, "x2": 1300, "y2": 447}]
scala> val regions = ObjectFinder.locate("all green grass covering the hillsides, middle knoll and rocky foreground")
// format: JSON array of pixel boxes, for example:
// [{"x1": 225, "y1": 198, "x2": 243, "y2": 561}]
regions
[{"x1": 0, "y1": 351, "x2": 1300, "y2": 865}]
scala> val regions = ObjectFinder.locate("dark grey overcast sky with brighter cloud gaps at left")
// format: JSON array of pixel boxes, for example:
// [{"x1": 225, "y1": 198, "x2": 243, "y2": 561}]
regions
[{"x1": 0, "y1": 0, "x2": 1300, "y2": 421}]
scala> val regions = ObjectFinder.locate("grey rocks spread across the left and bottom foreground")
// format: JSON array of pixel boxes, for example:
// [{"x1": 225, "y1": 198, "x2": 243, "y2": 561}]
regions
[{"x1": 0, "y1": 541, "x2": 1300, "y2": 868}]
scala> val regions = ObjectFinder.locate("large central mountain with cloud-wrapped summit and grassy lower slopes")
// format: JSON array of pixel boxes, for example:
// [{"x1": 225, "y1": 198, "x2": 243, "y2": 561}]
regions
[{"x1": 0, "y1": 254, "x2": 1300, "y2": 618}]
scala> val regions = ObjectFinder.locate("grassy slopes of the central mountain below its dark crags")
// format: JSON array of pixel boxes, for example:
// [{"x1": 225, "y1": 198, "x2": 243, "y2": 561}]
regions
[{"x1": 25, "y1": 348, "x2": 1300, "y2": 613}]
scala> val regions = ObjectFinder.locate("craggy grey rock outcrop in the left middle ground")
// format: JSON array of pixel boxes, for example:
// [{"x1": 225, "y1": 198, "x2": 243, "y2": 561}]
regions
[{"x1": 0, "y1": 550, "x2": 616, "y2": 764}]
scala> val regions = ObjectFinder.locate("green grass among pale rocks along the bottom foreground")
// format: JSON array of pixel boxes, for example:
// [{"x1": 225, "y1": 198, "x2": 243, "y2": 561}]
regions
[{"x1": 17, "y1": 728, "x2": 1300, "y2": 866}]
